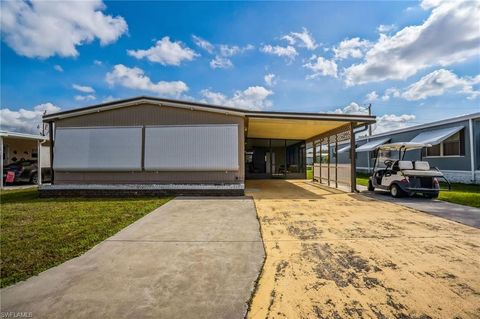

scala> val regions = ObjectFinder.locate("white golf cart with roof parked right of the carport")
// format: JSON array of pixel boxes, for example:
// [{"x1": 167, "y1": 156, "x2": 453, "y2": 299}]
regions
[{"x1": 368, "y1": 142, "x2": 450, "y2": 198}]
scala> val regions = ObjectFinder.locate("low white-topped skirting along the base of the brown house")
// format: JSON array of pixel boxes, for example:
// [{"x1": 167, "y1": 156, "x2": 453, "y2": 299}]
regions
[{"x1": 39, "y1": 183, "x2": 245, "y2": 198}]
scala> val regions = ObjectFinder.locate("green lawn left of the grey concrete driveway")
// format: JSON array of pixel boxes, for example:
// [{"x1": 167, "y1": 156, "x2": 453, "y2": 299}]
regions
[{"x1": 0, "y1": 189, "x2": 170, "y2": 287}]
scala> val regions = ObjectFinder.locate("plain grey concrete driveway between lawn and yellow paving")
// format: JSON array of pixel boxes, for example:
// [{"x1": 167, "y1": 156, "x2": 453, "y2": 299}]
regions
[{"x1": 1, "y1": 198, "x2": 264, "y2": 318}]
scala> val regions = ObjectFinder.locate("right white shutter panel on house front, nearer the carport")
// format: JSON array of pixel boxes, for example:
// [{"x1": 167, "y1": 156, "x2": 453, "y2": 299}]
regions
[{"x1": 145, "y1": 124, "x2": 239, "y2": 171}]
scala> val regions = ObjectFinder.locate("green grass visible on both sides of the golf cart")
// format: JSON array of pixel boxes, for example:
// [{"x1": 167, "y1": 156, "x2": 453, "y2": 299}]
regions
[{"x1": 357, "y1": 173, "x2": 480, "y2": 208}]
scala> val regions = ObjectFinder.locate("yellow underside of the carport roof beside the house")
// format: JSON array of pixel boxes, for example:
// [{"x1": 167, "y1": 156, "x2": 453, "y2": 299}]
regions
[{"x1": 247, "y1": 117, "x2": 350, "y2": 140}]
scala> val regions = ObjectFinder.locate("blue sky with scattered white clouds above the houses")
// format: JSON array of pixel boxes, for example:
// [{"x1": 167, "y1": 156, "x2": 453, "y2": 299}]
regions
[{"x1": 0, "y1": 0, "x2": 480, "y2": 133}]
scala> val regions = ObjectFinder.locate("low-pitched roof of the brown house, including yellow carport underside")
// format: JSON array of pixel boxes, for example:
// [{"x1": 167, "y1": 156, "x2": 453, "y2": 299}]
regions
[{"x1": 43, "y1": 96, "x2": 375, "y2": 140}]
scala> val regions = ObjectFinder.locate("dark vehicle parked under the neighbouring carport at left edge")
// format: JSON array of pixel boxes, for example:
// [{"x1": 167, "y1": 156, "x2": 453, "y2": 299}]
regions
[{"x1": 3, "y1": 160, "x2": 51, "y2": 184}]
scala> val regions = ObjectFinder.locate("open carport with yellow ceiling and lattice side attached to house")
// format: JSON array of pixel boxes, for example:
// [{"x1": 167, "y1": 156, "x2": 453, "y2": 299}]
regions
[{"x1": 245, "y1": 112, "x2": 375, "y2": 191}]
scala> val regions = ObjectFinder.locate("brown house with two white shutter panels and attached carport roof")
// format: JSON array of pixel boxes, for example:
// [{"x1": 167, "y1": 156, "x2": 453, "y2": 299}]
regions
[{"x1": 41, "y1": 97, "x2": 375, "y2": 196}]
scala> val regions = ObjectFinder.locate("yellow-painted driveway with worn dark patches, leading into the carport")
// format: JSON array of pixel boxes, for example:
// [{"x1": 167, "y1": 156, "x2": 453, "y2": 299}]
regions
[{"x1": 247, "y1": 180, "x2": 480, "y2": 319}]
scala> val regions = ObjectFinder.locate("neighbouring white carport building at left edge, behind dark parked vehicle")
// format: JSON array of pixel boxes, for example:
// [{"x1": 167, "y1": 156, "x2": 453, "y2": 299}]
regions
[{"x1": 0, "y1": 131, "x2": 50, "y2": 186}]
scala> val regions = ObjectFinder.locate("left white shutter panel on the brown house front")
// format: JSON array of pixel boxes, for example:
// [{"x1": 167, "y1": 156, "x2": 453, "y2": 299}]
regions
[{"x1": 53, "y1": 127, "x2": 142, "y2": 171}]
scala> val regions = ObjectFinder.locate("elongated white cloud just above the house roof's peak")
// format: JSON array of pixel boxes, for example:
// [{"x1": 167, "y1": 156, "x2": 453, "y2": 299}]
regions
[{"x1": 105, "y1": 64, "x2": 188, "y2": 96}]
